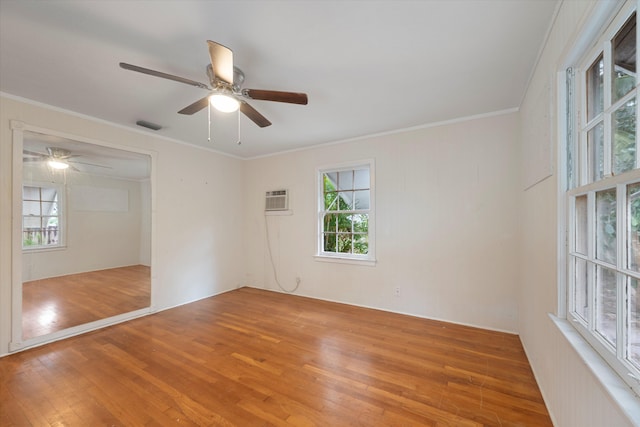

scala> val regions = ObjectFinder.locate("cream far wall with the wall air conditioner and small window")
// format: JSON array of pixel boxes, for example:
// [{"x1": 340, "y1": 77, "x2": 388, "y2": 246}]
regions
[{"x1": 244, "y1": 113, "x2": 519, "y2": 332}]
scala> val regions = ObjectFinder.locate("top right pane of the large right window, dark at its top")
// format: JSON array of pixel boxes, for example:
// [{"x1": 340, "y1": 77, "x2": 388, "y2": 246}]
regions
[{"x1": 613, "y1": 14, "x2": 636, "y2": 101}]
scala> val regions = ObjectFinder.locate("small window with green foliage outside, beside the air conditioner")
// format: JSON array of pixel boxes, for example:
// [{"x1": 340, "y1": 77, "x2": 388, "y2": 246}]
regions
[{"x1": 318, "y1": 161, "x2": 375, "y2": 261}]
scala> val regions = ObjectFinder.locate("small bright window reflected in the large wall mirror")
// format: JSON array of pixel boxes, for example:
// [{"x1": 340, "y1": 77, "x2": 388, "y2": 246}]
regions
[{"x1": 22, "y1": 185, "x2": 62, "y2": 250}]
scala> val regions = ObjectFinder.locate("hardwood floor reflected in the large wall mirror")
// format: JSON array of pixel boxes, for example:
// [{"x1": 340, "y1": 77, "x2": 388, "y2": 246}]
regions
[{"x1": 22, "y1": 265, "x2": 151, "y2": 339}]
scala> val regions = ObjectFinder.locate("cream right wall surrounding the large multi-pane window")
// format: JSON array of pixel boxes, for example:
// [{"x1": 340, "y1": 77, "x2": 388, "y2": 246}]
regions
[{"x1": 518, "y1": 1, "x2": 632, "y2": 427}]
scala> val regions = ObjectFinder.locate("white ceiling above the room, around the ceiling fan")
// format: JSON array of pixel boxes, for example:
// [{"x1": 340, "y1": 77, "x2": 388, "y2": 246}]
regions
[{"x1": 0, "y1": 0, "x2": 558, "y2": 158}]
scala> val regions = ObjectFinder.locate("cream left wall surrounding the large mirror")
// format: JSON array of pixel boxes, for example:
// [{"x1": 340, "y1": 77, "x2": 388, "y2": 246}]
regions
[{"x1": 0, "y1": 97, "x2": 244, "y2": 356}]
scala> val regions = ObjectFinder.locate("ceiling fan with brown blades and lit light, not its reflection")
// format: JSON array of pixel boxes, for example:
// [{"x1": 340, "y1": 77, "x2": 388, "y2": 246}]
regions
[{"x1": 120, "y1": 40, "x2": 308, "y2": 127}]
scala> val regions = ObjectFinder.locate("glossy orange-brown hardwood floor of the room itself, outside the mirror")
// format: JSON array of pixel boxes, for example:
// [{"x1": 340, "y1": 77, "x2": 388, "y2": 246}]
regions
[{"x1": 0, "y1": 288, "x2": 551, "y2": 427}]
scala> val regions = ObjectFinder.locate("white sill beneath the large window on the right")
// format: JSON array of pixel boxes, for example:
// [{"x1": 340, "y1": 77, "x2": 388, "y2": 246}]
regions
[{"x1": 549, "y1": 314, "x2": 640, "y2": 423}]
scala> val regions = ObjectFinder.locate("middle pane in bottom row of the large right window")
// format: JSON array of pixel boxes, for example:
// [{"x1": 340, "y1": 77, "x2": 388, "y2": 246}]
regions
[{"x1": 596, "y1": 266, "x2": 617, "y2": 346}]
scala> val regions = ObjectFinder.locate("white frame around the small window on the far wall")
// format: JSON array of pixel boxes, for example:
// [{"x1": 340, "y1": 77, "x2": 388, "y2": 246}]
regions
[{"x1": 315, "y1": 159, "x2": 376, "y2": 266}]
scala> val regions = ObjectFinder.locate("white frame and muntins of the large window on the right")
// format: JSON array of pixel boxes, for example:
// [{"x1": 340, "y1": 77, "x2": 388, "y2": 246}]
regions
[{"x1": 558, "y1": 0, "x2": 640, "y2": 395}]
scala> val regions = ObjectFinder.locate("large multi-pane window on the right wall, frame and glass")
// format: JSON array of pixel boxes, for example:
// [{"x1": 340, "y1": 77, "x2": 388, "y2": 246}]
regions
[{"x1": 565, "y1": 2, "x2": 640, "y2": 393}]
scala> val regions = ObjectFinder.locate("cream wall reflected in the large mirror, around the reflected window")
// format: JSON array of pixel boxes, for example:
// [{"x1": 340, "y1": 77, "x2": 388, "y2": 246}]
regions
[{"x1": 22, "y1": 169, "x2": 151, "y2": 282}]
